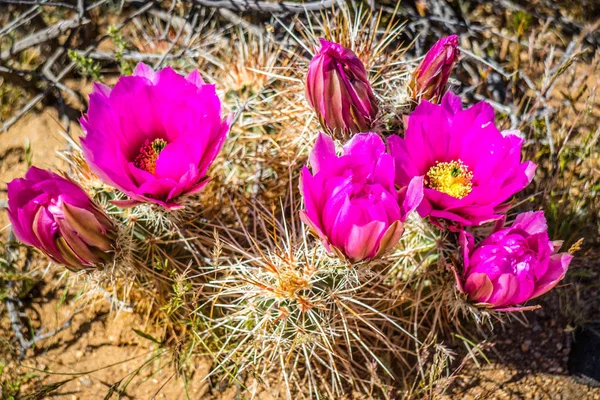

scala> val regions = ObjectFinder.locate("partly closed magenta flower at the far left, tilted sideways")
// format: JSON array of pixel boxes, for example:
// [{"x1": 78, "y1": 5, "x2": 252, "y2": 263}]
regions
[{"x1": 8, "y1": 167, "x2": 116, "y2": 271}]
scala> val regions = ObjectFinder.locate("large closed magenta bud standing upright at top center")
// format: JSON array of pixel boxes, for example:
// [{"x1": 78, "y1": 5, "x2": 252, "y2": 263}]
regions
[{"x1": 306, "y1": 39, "x2": 377, "y2": 138}]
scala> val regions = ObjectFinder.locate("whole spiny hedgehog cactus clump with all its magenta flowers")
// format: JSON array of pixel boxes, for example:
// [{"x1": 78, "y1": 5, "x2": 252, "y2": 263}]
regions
[{"x1": 8, "y1": 7, "x2": 571, "y2": 398}]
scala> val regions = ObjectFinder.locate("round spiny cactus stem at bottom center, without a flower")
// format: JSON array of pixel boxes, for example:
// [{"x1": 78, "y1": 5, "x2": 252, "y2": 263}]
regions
[{"x1": 209, "y1": 206, "x2": 414, "y2": 398}]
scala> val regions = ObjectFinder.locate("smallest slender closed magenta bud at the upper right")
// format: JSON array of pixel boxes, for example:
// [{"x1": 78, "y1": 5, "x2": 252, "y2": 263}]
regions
[{"x1": 408, "y1": 35, "x2": 460, "y2": 103}]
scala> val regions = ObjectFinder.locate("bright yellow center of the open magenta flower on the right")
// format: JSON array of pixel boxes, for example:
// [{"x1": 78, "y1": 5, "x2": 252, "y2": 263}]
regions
[{"x1": 427, "y1": 160, "x2": 473, "y2": 199}]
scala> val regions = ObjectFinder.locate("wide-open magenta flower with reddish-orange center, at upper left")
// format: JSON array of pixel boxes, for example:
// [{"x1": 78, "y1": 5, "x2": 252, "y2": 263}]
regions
[{"x1": 81, "y1": 63, "x2": 231, "y2": 209}]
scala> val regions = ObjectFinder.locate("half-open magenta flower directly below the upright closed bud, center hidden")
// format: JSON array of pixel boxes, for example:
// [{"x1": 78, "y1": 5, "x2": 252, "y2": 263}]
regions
[{"x1": 300, "y1": 133, "x2": 423, "y2": 262}]
